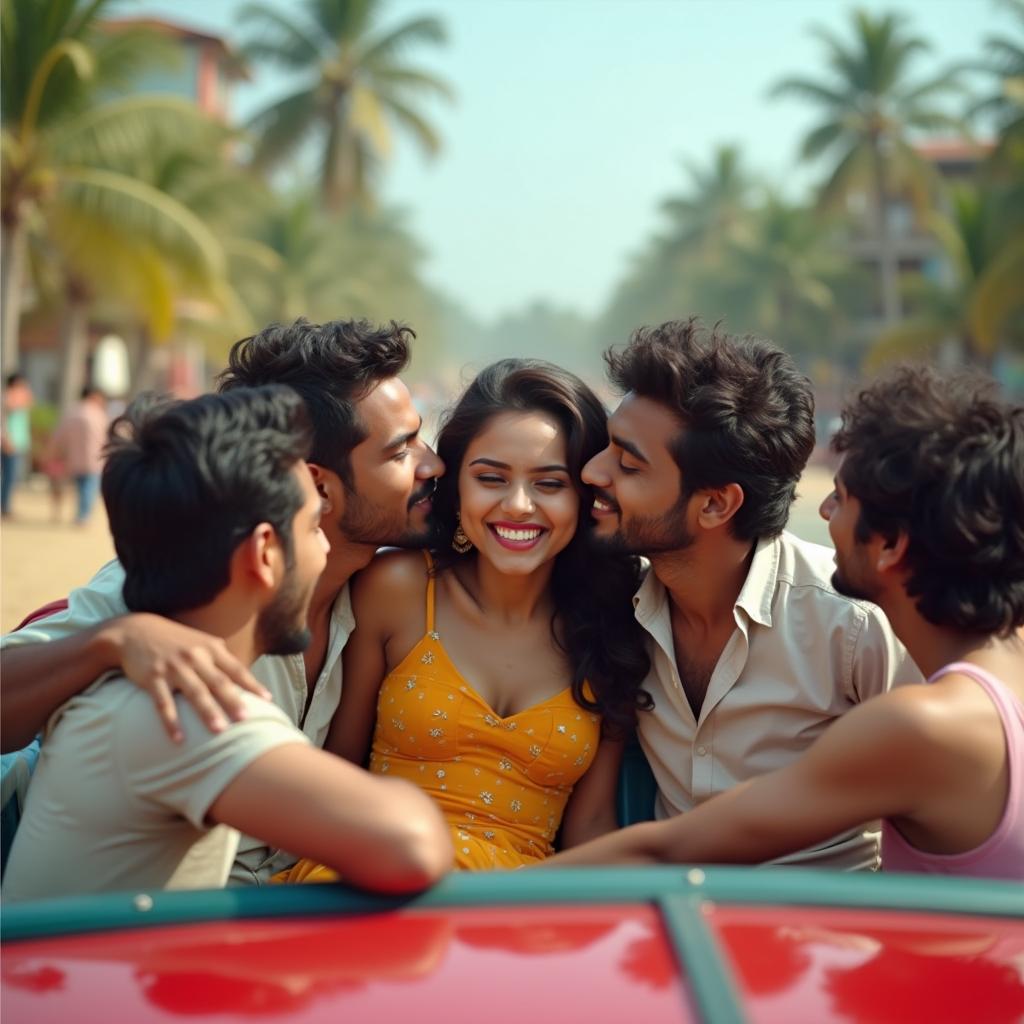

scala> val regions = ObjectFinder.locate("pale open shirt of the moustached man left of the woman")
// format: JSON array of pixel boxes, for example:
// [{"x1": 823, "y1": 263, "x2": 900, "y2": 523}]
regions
[{"x1": 0, "y1": 559, "x2": 355, "y2": 884}]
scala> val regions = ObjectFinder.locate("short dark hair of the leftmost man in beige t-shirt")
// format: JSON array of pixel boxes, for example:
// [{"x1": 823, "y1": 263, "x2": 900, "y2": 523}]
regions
[{"x1": 101, "y1": 386, "x2": 311, "y2": 615}]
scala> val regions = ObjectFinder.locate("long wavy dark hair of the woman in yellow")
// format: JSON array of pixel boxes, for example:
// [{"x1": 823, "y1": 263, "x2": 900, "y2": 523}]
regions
[{"x1": 432, "y1": 359, "x2": 653, "y2": 735}]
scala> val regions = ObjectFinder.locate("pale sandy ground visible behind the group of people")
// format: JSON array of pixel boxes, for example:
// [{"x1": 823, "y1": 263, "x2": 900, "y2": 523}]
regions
[{"x1": 0, "y1": 467, "x2": 831, "y2": 633}]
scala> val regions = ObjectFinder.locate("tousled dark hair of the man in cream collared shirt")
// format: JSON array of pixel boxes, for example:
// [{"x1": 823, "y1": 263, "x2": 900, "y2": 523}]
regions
[{"x1": 604, "y1": 317, "x2": 814, "y2": 541}]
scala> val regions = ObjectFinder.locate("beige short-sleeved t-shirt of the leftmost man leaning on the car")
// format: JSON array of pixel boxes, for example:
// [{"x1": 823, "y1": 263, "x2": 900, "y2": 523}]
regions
[{"x1": 3, "y1": 674, "x2": 309, "y2": 901}]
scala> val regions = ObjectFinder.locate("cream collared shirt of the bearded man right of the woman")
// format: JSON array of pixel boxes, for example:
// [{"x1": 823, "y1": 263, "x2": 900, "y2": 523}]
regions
[{"x1": 633, "y1": 532, "x2": 921, "y2": 869}]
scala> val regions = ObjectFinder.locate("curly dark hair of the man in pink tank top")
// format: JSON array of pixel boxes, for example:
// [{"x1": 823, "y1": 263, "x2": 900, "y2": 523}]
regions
[{"x1": 831, "y1": 366, "x2": 1024, "y2": 636}]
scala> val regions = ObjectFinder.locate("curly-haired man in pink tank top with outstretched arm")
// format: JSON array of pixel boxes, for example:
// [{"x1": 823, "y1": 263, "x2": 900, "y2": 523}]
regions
[{"x1": 557, "y1": 367, "x2": 1024, "y2": 882}]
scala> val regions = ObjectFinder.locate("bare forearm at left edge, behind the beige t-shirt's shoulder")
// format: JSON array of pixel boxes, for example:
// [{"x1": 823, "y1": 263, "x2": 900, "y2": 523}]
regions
[{"x1": 0, "y1": 623, "x2": 119, "y2": 754}]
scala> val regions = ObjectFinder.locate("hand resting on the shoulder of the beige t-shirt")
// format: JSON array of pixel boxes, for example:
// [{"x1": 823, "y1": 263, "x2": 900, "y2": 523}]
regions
[{"x1": 102, "y1": 612, "x2": 271, "y2": 742}]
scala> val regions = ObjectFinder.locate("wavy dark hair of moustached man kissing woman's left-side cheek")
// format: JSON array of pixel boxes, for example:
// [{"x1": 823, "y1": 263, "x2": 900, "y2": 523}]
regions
[{"x1": 218, "y1": 317, "x2": 416, "y2": 490}]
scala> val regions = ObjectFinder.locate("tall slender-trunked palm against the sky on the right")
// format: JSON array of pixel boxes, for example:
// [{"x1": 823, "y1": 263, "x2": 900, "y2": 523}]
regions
[{"x1": 772, "y1": 10, "x2": 961, "y2": 324}]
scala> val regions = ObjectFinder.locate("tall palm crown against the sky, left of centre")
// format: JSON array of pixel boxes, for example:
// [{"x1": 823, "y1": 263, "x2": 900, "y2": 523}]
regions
[{"x1": 242, "y1": 0, "x2": 451, "y2": 212}]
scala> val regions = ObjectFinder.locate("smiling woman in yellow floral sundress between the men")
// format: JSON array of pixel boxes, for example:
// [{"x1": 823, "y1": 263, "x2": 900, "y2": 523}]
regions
[{"x1": 278, "y1": 359, "x2": 647, "y2": 881}]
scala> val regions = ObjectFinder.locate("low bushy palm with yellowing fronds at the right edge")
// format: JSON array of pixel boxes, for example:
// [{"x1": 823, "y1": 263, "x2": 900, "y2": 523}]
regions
[{"x1": 868, "y1": 185, "x2": 1024, "y2": 368}]
